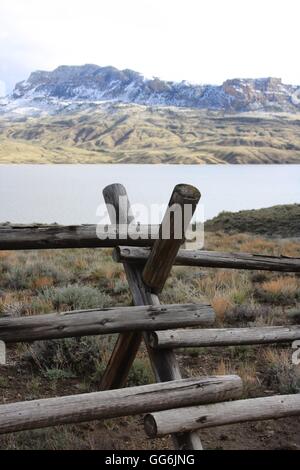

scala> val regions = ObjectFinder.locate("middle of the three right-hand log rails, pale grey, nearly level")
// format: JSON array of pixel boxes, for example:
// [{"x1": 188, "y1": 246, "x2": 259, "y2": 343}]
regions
[{"x1": 150, "y1": 325, "x2": 300, "y2": 349}]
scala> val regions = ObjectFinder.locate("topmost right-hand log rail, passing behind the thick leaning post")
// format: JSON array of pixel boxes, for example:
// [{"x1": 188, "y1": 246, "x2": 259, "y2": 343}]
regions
[{"x1": 115, "y1": 246, "x2": 300, "y2": 272}]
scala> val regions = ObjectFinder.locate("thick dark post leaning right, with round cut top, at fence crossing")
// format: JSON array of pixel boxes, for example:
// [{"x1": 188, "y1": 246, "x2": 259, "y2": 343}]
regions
[{"x1": 143, "y1": 184, "x2": 200, "y2": 293}]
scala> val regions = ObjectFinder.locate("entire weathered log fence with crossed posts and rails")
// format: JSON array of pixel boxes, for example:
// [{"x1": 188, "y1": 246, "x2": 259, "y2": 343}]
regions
[{"x1": 0, "y1": 184, "x2": 300, "y2": 450}]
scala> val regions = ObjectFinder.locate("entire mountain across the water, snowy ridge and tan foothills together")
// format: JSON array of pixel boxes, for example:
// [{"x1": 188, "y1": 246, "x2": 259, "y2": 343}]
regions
[{"x1": 0, "y1": 65, "x2": 300, "y2": 164}]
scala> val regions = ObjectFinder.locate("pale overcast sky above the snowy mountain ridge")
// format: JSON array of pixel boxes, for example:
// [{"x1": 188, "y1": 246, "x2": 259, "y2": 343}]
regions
[{"x1": 0, "y1": 0, "x2": 300, "y2": 94}]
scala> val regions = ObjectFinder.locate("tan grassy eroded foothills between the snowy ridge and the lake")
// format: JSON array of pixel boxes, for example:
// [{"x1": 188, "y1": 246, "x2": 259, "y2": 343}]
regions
[{"x1": 0, "y1": 104, "x2": 300, "y2": 164}]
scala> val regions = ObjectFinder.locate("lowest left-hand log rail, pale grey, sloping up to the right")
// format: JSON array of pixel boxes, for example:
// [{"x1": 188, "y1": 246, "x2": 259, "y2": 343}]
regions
[{"x1": 0, "y1": 375, "x2": 242, "y2": 434}]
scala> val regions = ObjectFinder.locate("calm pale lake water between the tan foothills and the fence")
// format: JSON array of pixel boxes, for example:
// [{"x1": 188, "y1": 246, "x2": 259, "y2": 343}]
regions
[{"x1": 0, "y1": 165, "x2": 300, "y2": 224}]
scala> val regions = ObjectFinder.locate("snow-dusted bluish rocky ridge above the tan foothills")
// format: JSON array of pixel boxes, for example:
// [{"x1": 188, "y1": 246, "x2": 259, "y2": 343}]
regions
[{"x1": 0, "y1": 65, "x2": 300, "y2": 115}]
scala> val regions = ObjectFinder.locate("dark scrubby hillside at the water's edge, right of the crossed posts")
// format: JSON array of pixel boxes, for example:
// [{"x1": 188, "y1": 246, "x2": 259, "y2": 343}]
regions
[{"x1": 205, "y1": 204, "x2": 300, "y2": 238}]
